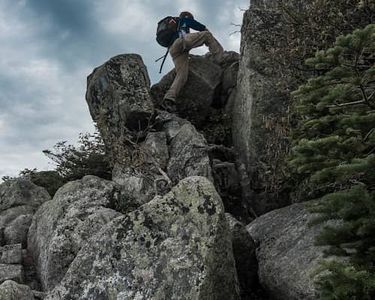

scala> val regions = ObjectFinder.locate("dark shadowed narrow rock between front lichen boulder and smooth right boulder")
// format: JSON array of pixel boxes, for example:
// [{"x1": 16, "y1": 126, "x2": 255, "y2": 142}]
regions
[{"x1": 225, "y1": 213, "x2": 259, "y2": 299}]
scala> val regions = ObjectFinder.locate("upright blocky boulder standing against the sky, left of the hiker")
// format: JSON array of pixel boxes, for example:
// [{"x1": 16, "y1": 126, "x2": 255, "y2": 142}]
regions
[{"x1": 86, "y1": 54, "x2": 154, "y2": 166}]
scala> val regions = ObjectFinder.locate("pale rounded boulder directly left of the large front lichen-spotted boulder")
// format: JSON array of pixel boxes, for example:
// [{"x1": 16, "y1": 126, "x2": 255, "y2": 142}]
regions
[{"x1": 28, "y1": 176, "x2": 121, "y2": 290}]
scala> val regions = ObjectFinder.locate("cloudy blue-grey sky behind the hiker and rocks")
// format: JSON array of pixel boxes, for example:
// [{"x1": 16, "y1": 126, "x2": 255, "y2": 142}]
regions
[{"x1": 0, "y1": 0, "x2": 249, "y2": 181}]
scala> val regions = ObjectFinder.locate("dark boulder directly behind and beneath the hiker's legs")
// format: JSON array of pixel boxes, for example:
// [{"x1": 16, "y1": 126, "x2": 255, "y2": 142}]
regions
[{"x1": 151, "y1": 55, "x2": 222, "y2": 126}]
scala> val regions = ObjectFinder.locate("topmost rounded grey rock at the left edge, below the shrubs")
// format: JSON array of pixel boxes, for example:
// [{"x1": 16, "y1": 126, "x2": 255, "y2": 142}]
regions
[{"x1": 0, "y1": 178, "x2": 51, "y2": 212}]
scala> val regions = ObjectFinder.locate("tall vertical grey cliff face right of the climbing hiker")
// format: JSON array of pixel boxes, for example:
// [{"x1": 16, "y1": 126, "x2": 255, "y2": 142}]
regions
[{"x1": 231, "y1": 0, "x2": 294, "y2": 215}]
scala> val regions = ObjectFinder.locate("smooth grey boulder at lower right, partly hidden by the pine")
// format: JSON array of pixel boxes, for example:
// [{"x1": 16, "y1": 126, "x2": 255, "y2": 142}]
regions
[{"x1": 247, "y1": 203, "x2": 323, "y2": 300}]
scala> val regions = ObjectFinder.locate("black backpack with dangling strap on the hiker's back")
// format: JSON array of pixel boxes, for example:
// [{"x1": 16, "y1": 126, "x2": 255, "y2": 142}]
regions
[{"x1": 155, "y1": 16, "x2": 180, "y2": 73}]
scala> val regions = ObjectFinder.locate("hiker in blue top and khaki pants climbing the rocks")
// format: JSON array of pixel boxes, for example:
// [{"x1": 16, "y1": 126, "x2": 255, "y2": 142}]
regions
[{"x1": 157, "y1": 11, "x2": 224, "y2": 104}]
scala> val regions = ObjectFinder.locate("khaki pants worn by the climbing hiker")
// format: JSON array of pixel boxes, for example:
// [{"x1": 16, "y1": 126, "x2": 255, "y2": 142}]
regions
[{"x1": 164, "y1": 31, "x2": 224, "y2": 100}]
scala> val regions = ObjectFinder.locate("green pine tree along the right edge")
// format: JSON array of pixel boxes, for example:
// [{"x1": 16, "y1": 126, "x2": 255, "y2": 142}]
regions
[{"x1": 289, "y1": 24, "x2": 375, "y2": 300}]
